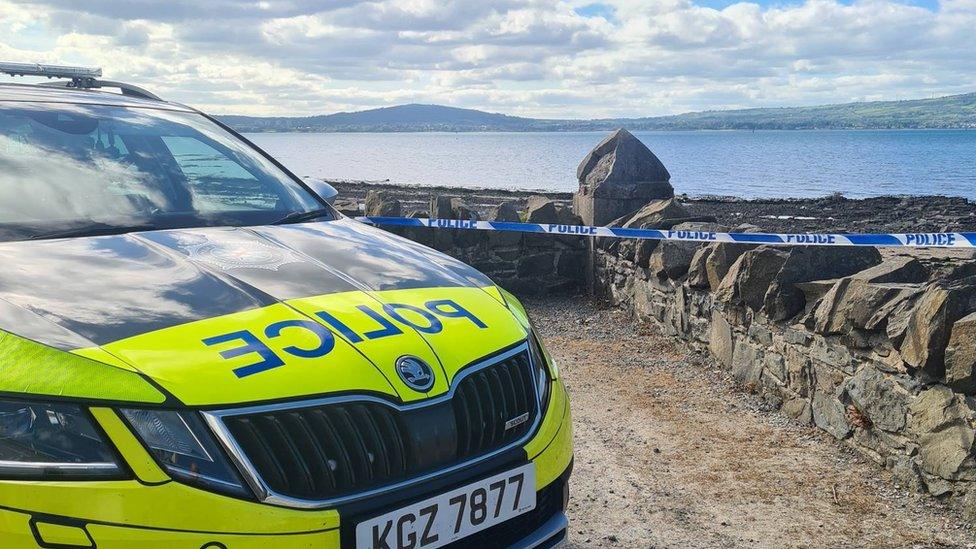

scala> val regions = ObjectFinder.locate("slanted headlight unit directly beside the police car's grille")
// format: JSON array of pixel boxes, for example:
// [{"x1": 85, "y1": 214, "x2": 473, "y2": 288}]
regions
[{"x1": 122, "y1": 410, "x2": 251, "y2": 496}]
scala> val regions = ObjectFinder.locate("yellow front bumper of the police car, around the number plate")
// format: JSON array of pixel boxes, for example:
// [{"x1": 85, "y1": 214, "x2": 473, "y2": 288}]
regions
[{"x1": 0, "y1": 381, "x2": 572, "y2": 549}]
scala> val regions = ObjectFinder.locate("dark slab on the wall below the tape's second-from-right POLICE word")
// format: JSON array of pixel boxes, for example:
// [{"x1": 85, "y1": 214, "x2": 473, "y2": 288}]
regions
[{"x1": 763, "y1": 246, "x2": 881, "y2": 321}]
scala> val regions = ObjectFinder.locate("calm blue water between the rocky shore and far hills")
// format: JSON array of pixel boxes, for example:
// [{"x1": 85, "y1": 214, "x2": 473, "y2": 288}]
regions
[{"x1": 249, "y1": 130, "x2": 976, "y2": 199}]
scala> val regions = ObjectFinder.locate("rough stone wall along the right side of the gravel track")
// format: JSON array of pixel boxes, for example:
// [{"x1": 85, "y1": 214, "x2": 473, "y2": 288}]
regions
[{"x1": 593, "y1": 198, "x2": 976, "y2": 515}]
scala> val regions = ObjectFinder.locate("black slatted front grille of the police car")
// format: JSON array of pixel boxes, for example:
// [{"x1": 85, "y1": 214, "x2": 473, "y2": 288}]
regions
[{"x1": 222, "y1": 351, "x2": 538, "y2": 501}]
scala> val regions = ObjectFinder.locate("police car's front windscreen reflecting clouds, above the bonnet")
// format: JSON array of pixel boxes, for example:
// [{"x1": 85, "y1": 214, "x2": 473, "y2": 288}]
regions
[{"x1": 0, "y1": 102, "x2": 322, "y2": 240}]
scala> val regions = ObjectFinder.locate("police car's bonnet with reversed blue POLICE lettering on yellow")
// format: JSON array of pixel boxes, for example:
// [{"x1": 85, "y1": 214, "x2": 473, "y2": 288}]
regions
[{"x1": 0, "y1": 219, "x2": 528, "y2": 406}]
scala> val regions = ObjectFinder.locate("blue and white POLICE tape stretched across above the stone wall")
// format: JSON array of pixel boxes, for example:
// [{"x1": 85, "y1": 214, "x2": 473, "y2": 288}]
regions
[{"x1": 356, "y1": 217, "x2": 976, "y2": 248}]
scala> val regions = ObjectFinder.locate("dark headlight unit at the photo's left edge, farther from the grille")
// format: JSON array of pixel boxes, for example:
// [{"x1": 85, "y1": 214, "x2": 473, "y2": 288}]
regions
[{"x1": 0, "y1": 400, "x2": 127, "y2": 480}]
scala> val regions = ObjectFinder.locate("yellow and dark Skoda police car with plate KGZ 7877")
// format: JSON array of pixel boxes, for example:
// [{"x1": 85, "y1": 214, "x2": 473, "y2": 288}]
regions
[{"x1": 0, "y1": 63, "x2": 572, "y2": 549}]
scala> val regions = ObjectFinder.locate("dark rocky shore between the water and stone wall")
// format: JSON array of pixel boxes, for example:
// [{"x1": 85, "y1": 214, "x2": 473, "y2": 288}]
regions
[{"x1": 328, "y1": 180, "x2": 976, "y2": 233}]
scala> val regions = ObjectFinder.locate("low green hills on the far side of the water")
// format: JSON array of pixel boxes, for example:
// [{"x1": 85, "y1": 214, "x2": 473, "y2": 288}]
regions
[{"x1": 220, "y1": 93, "x2": 976, "y2": 132}]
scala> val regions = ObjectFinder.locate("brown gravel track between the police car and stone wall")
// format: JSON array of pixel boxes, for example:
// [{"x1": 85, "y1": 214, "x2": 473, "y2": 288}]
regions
[{"x1": 527, "y1": 297, "x2": 976, "y2": 549}]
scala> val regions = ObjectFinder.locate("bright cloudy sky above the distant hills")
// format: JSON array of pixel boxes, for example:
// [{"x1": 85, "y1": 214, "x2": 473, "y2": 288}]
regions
[{"x1": 0, "y1": 0, "x2": 976, "y2": 118}]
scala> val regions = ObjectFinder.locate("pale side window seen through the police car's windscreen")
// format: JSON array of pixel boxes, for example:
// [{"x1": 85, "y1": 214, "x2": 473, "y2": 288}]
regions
[{"x1": 162, "y1": 136, "x2": 279, "y2": 212}]
